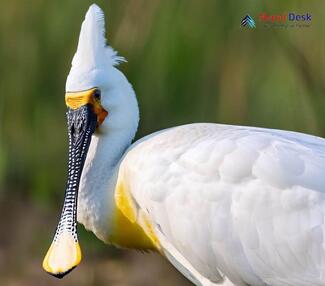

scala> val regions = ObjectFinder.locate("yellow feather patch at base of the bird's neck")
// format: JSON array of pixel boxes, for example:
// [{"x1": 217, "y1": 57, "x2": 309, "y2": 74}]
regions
[{"x1": 110, "y1": 180, "x2": 160, "y2": 251}]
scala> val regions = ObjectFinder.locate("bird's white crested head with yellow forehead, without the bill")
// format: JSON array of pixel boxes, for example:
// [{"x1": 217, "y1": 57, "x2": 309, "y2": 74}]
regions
[{"x1": 65, "y1": 4, "x2": 125, "y2": 132}]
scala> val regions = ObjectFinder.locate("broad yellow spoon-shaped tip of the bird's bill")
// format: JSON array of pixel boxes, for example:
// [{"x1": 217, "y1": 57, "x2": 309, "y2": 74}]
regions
[{"x1": 43, "y1": 233, "x2": 82, "y2": 278}]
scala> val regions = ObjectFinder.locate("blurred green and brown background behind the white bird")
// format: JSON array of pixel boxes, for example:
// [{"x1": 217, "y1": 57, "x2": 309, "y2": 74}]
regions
[{"x1": 0, "y1": 0, "x2": 325, "y2": 286}]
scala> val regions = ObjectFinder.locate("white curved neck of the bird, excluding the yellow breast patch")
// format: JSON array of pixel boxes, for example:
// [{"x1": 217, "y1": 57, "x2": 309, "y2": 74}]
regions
[{"x1": 77, "y1": 79, "x2": 144, "y2": 246}]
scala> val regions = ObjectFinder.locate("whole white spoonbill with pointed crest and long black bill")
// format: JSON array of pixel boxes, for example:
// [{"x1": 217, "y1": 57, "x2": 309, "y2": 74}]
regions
[{"x1": 43, "y1": 5, "x2": 325, "y2": 286}]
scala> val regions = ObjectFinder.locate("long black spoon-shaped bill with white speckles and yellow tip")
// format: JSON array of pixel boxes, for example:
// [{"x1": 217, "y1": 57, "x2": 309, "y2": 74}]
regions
[{"x1": 43, "y1": 104, "x2": 97, "y2": 278}]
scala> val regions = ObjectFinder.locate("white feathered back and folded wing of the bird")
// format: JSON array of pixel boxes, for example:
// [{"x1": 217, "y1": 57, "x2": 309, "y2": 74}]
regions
[{"x1": 121, "y1": 124, "x2": 325, "y2": 286}]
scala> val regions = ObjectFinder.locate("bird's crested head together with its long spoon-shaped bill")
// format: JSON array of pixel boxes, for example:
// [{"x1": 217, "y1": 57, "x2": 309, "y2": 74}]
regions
[{"x1": 43, "y1": 4, "x2": 138, "y2": 278}]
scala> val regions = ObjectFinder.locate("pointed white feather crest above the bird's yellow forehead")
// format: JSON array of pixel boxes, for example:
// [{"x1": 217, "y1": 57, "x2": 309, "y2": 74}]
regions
[{"x1": 66, "y1": 4, "x2": 125, "y2": 92}]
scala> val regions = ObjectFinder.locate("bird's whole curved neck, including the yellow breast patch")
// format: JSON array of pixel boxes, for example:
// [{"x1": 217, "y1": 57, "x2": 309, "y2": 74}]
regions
[{"x1": 77, "y1": 77, "x2": 157, "y2": 249}]
